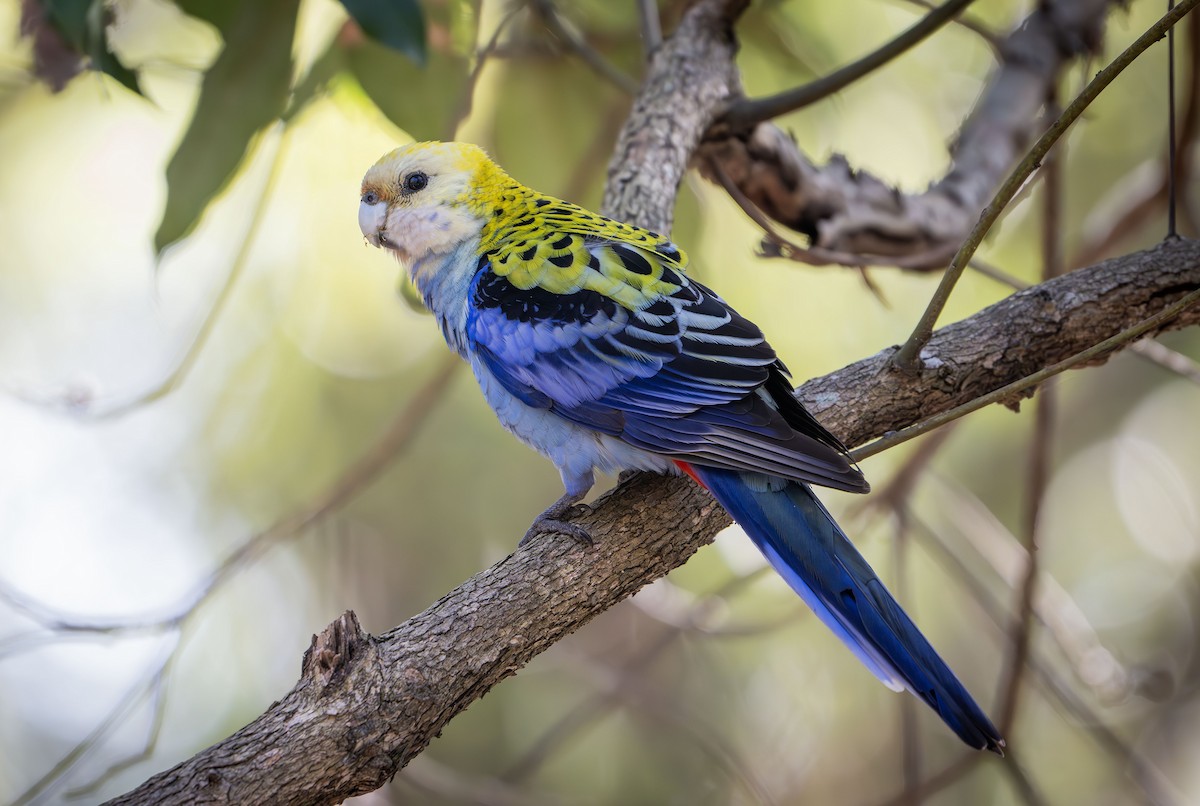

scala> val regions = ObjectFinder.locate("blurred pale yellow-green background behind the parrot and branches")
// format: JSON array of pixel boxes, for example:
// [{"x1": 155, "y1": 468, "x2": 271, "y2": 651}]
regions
[{"x1": 0, "y1": 0, "x2": 1200, "y2": 804}]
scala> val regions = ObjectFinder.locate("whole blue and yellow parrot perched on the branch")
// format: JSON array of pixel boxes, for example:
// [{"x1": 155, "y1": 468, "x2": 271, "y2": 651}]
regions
[{"x1": 359, "y1": 142, "x2": 1004, "y2": 756}]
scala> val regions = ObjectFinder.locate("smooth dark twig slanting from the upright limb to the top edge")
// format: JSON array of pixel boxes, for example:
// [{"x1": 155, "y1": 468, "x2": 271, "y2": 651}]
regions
[{"x1": 721, "y1": 0, "x2": 974, "y2": 132}]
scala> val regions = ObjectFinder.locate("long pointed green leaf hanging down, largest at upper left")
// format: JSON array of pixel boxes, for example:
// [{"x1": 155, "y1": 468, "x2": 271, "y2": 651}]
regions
[{"x1": 154, "y1": 0, "x2": 300, "y2": 254}]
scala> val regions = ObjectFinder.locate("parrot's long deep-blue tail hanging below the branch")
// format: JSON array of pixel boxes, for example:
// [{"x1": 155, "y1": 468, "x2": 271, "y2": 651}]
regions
[{"x1": 686, "y1": 465, "x2": 1004, "y2": 756}]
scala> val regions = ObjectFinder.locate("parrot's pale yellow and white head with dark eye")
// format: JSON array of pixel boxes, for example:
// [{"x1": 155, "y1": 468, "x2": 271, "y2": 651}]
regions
[{"x1": 359, "y1": 143, "x2": 511, "y2": 266}]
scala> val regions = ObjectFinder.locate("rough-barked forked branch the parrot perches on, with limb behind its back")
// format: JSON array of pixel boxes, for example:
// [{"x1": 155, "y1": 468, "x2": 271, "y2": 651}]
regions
[{"x1": 110, "y1": 0, "x2": 1200, "y2": 804}]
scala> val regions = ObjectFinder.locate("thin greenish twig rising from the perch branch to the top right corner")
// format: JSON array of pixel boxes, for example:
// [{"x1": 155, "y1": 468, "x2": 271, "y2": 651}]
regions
[{"x1": 892, "y1": 0, "x2": 1200, "y2": 371}]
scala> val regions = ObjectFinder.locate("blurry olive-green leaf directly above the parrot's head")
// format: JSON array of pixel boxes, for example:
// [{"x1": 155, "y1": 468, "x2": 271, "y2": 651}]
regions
[{"x1": 346, "y1": 41, "x2": 467, "y2": 140}]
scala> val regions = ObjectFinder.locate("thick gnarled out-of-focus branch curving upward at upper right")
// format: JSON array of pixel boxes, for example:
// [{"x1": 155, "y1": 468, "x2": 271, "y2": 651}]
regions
[{"x1": 697, "y1": 0, "x2": 1118, "y2": 269}]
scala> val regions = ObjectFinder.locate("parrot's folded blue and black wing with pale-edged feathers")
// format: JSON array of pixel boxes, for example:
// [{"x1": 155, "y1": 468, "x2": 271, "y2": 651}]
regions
[{"x1": 467, "y1": 241, "x2": 868, "y2": 492}]
